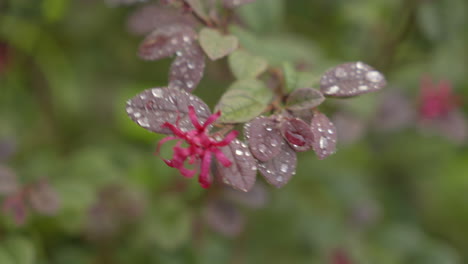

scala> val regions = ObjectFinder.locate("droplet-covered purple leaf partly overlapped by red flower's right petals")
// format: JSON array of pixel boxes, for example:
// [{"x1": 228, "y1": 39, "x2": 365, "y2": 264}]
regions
[{"x1": 217, "y1": 139, "x2": 257, "y2": 192}]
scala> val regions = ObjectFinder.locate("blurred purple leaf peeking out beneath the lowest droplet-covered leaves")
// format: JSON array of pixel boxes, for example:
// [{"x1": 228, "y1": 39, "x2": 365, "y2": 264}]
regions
[{"x1": 223, "y1": 181, "x2": 268, "y2": 208}]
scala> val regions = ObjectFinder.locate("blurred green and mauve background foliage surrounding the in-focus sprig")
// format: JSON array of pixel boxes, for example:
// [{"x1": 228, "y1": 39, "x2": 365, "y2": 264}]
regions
[{"x1": 0, "y1": 0, "x2": 468, "y2": 264}]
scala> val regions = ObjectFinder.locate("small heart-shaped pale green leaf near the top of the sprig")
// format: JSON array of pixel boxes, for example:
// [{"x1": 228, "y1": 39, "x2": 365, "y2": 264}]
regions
[{"x1": 199, "y1": 28, "x2": 239, "y2": 60}]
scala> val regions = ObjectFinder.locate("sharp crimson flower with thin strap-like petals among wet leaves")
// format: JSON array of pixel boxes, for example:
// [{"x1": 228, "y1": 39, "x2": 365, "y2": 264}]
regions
[{"x1": 157, "y1": 106, "x2": 238, "y2": 188}]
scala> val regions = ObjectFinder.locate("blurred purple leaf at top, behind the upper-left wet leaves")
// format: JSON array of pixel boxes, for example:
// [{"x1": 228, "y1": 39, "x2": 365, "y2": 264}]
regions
[{"x1": 127, "y1": 4, "x2": 197, "y2": 35}]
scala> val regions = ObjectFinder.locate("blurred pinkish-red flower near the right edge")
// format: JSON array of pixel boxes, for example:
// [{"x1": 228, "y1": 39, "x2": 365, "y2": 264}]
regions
[{"x1": 419, "y1": 76, "x2": 457, "y2": 119}]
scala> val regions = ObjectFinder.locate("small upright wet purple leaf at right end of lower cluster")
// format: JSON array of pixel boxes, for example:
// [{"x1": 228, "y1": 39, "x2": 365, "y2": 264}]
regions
[{"x1": 311, "y1": 113, "x2": 337, "y2": 159}]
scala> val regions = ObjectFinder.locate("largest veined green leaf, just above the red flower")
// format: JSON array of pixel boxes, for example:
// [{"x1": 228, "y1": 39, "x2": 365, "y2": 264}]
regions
[{"x1": 216, "y1": 79, "x2": 273, "y2": 123}]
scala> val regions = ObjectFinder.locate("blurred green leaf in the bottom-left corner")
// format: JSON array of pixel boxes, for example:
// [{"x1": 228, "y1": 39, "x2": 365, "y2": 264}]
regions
[{"x1": 0, "y1": 236, "x2": 36, "y2": 264}]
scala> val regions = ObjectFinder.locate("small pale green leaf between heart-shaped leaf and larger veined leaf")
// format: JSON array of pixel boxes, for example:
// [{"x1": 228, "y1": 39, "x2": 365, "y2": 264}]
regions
[{"x1": 229, "y1": 50, "x2": 268, "y2": 79}]
